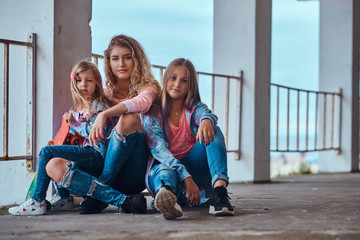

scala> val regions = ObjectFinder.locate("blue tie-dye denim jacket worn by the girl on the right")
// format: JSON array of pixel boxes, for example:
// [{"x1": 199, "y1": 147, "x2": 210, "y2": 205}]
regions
[{"x1": 142, "y1": 101, "x2": 218, "y2": 193}]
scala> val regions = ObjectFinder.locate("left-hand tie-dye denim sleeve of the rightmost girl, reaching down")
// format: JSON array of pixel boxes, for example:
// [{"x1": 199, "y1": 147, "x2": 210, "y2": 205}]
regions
[{"x1": 144, "y1": 113, "x2": 191, "y2": 181}]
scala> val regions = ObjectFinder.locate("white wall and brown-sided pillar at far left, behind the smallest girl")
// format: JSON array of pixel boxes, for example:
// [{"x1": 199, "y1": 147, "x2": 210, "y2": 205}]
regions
[{"x1": 0, "y1": 0, "x2": 91, "y2": 206}]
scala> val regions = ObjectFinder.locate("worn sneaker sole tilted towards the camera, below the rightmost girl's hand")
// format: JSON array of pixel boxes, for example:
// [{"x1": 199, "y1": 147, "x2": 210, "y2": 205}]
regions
[{"x1": 154, "y1": 188, "x2": 183, "y2": 220}]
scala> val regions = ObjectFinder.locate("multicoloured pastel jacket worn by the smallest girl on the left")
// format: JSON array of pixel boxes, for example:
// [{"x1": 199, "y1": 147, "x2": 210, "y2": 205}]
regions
[{"x1": 69, "y1": 100, "x2": 114, "y2": 158}]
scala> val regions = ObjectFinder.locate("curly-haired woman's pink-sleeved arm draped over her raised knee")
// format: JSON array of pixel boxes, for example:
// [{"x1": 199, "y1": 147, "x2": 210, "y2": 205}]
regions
[{"x1": 89, "y1": 87, "x2": 158, "y2": 146}]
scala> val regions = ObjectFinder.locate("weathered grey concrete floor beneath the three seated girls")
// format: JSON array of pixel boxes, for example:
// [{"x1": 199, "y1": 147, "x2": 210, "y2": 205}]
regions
[{"x1": 0, "y1": 173, "x2": 360, "y2": 240}]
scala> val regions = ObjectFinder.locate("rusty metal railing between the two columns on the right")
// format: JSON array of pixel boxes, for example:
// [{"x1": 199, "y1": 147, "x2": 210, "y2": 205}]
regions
[{"x1": 270, "y1": 84, "x2": 342, "y2": 152}]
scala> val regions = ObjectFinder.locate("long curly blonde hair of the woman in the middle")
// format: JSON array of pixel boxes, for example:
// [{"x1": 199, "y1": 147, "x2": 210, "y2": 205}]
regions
[{"x1": 104, "y1": 35, "x2": 160, "y2": 96}]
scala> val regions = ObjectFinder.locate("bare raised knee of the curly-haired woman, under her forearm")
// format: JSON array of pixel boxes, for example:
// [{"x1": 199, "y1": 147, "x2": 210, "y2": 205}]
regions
[{"x1": 115, "y1": 113, "x2": 143, "y2": 134}]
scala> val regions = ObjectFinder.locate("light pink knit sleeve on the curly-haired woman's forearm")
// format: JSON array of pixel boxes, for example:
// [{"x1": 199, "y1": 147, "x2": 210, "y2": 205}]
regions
[{"x1": 121, "y1": 87, "x2": 157, "y2": 113}]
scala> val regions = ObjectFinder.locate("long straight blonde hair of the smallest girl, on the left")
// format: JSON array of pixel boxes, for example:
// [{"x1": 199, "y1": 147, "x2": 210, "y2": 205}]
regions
[{"x1": 70, "y1": 60, "x2": 112, "y2": 112}]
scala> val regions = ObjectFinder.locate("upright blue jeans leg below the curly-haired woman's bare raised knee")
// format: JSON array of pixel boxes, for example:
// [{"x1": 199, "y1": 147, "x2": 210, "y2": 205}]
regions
[{"x1": 99, "y1": 129, "x2": 149, "y2": 194}]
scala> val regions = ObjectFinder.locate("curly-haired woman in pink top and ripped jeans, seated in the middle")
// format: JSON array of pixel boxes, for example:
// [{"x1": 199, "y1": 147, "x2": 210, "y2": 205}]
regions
[{"x1": 63, "y1": 35, "x2": 160, "y2": 214}]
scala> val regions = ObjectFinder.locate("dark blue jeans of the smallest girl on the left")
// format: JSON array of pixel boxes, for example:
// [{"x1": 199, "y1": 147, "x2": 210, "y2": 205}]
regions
[{"x1": 33, "y1": 145, "x2": 104, "y2": 202}]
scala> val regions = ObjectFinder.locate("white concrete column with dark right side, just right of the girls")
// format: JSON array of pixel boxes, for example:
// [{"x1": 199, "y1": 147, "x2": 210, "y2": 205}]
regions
[{"x1": 213, "y1": 0, "x2": 271, "y2": 182}]
